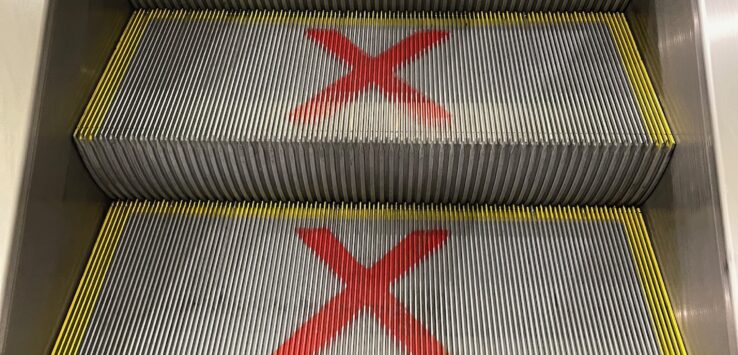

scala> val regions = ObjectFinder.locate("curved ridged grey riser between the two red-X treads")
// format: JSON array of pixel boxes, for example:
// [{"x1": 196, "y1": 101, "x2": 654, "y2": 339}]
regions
[{"x1": 80, "y1": 142, "x2": 668, "y2": 205}]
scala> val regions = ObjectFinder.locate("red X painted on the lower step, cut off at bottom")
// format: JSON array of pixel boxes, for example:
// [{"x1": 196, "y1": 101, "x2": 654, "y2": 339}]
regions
[{"x1": 276, "y1": 228, "x2": 448, "y2": 355}]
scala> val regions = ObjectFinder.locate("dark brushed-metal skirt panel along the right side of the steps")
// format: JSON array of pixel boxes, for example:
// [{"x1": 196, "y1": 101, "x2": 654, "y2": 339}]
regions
[{"x1": 629, "y1": 0, "x2": 736, "y2": 354}]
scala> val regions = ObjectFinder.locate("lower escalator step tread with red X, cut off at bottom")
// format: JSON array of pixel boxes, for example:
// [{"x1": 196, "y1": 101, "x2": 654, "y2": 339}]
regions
[{"x1": 53, "y1": 202, "x2": 685, "y2": 354}]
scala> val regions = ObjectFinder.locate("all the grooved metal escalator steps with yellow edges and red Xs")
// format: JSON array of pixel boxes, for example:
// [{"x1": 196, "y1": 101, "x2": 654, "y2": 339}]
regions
[{"x1": 52, "y1": 0, "x2": 686, "y2": 354}]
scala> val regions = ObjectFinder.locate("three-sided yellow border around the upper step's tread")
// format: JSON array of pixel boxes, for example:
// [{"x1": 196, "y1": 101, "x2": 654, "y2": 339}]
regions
[{"x1": 75, "y1": 10, "x2": 674, "y2": 147}]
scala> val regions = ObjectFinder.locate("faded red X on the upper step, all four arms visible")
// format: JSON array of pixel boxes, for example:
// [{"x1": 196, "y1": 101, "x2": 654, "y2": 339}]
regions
[{"x1": 290, "y1": 29, "x2": 451, "y2": 124}]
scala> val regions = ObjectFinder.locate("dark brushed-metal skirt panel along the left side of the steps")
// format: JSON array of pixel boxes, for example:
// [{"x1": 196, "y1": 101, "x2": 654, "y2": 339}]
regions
[{"x1": 0, "y1": 0, "x2": 130, "y2": 354}]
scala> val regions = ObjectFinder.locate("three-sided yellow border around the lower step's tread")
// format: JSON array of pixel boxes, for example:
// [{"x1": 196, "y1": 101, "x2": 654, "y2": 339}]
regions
[{"x1": 52, "y1": 202, "x2": 686, "y2": 354}]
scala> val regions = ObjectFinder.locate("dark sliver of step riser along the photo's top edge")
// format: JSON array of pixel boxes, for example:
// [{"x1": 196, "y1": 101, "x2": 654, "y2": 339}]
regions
[{"x1": 131, "y1": 0, "x2": 630, "y2": 11}]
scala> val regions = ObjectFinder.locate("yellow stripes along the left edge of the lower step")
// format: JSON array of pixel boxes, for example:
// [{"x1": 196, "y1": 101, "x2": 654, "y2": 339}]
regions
[{"x1": 51, "y1": 203, "x2": 134, "y2": 354}]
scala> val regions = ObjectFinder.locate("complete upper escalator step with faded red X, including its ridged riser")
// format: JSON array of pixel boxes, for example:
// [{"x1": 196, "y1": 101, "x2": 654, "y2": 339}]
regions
[{"x1": 75, "y1": 11, "x2": 674, "y2": 205}]
